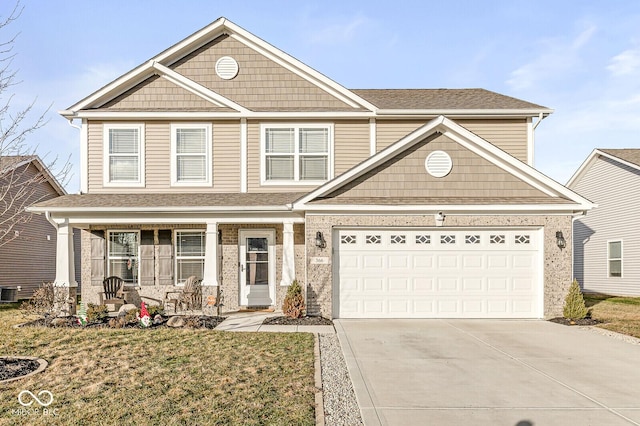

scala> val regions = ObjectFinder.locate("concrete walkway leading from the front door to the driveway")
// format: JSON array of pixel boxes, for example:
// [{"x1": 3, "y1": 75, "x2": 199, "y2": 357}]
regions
[{"x1": 215, "y1": 312, "x2": 335, "y2": 333}]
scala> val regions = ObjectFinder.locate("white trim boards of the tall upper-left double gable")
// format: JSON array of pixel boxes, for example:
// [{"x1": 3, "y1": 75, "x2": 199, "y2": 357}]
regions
[{"x1": 60, "y1": 18, "x2": 375, "y2": 119}]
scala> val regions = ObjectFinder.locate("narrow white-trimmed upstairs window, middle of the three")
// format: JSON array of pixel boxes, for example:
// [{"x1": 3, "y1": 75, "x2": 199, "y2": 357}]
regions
[{"x1": 171, "y1": 124, "x2": 211, "y2": 186}]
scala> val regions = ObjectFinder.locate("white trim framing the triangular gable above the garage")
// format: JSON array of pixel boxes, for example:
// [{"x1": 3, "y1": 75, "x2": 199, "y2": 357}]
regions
[{"x1": 293, "y1": 116, "x2": 592, "y2": 212}]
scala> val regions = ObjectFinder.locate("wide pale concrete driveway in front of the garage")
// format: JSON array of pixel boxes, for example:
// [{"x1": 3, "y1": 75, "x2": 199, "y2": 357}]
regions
[{"x1": 334, "y1": 320, "x2": 640, "y2": 426}]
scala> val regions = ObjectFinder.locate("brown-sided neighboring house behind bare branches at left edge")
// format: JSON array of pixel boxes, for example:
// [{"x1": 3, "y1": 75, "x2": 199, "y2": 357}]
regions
[{"x1": 0, "y1": 155, "x2": 80, "y2": 300}]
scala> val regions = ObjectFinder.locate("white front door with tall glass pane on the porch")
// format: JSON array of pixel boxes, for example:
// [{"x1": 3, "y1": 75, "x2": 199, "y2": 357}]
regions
[{"x1": 239, "y1": 229, "x2": 276, "y2": 306}]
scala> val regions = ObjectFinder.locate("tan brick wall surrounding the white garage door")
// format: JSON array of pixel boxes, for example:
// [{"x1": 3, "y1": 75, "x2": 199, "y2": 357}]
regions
[{"x1": 306, "y1": 214, "x2": 573, "y2": 318}]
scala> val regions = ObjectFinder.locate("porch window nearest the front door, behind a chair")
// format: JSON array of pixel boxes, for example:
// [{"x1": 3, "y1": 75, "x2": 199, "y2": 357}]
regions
[{"x1": 175, "y1": 231, "x2": 205, "y2": 284}]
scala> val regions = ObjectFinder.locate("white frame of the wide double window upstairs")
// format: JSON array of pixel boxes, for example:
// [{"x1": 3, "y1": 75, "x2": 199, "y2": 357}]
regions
[{"x1": 260, "y1": 122, "x2": 334, "y2": 186}]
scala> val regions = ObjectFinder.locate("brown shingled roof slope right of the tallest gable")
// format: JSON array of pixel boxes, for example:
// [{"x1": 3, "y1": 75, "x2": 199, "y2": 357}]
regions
[{"x1": 351, "y1": 89, "x2": 551, "y2": 112}]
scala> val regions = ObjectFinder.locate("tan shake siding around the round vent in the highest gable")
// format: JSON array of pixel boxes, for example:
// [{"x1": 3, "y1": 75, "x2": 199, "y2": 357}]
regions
[{"x1": 171, "y1": 36, "x2": 353, "y2": 111}]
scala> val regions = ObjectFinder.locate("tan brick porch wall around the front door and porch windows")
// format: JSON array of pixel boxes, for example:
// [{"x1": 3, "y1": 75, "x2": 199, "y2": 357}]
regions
[{"x1": 81, "y1": 224, "x2": 305, "y2": 315}]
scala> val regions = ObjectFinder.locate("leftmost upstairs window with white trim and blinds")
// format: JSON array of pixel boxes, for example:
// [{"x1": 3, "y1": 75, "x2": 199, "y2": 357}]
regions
[{"x1": 104, "y1": 123, "x2": 144, "y2": 186}]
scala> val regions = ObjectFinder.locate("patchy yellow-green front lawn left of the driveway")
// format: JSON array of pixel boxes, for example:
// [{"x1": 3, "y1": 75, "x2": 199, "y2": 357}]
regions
[{"x1": 0, "y1": 308, "x2": 315, "y2": 425}]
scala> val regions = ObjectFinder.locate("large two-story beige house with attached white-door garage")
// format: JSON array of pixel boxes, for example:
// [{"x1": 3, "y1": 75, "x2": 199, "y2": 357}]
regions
[{"x1": 27, "y1": 18, "x2": 591, "y2": 318}]
